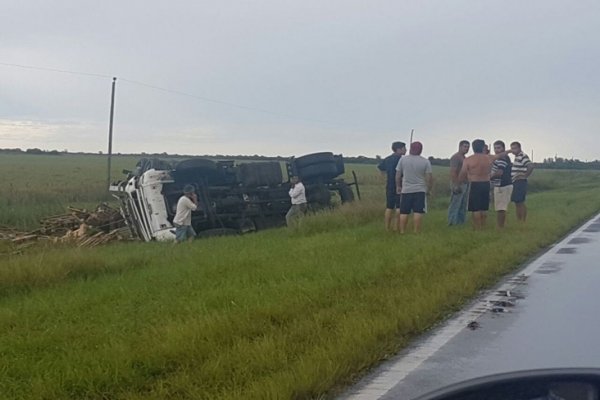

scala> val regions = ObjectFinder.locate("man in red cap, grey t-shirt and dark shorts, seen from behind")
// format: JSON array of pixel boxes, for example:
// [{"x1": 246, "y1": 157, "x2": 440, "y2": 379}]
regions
[{"x1": 396, "y1": 142, "x2": 433, "y2": 233}]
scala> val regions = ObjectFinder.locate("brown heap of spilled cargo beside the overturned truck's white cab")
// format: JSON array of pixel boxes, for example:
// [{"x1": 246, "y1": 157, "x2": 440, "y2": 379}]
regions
[{"x1": 0, "y1": 203, "x2": 131, "y2": 247}]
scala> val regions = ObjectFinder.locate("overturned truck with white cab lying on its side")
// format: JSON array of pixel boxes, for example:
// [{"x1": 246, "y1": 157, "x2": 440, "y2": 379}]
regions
[{"x1": 110, "y1": 152, "x2": 360, "y2": 241}]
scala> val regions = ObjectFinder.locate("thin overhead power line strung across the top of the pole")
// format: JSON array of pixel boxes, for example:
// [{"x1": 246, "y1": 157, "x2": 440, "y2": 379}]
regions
[{"x1": 0, "y1": 62, "x2": 340, "y2": 125}]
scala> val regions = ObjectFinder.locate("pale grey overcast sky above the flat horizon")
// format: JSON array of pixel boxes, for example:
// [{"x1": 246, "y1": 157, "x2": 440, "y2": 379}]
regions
[{"x1": 0, "y1": 0, "x2": 600, "y2": 160}]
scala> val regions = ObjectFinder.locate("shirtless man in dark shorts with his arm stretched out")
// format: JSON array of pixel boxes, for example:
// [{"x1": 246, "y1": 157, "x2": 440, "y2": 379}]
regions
[{"x1": 460, "y1": 139, "x2": 508, "y2": 230}]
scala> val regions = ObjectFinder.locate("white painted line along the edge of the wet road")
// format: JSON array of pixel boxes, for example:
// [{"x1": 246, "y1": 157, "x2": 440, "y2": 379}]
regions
[{"x1": 343, "y1": 214, "x2": 600, "y2": 400}]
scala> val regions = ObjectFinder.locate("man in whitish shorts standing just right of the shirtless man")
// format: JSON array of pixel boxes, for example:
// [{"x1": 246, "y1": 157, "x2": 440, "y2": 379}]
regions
[{"x1": 492, "y1": 140, "x2": 513, "y2": 229}]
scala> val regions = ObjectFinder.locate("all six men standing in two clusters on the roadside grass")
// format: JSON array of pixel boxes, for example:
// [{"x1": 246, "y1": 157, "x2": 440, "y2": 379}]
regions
[{"x1": 378, "y1": 139, "x2": 533, "y2": 233}]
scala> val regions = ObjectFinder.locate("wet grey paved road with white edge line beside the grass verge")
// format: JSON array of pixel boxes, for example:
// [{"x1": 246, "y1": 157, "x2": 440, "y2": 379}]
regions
[{"x1": 342, "y1": 216, "x2": 600, "y2": 400}]
